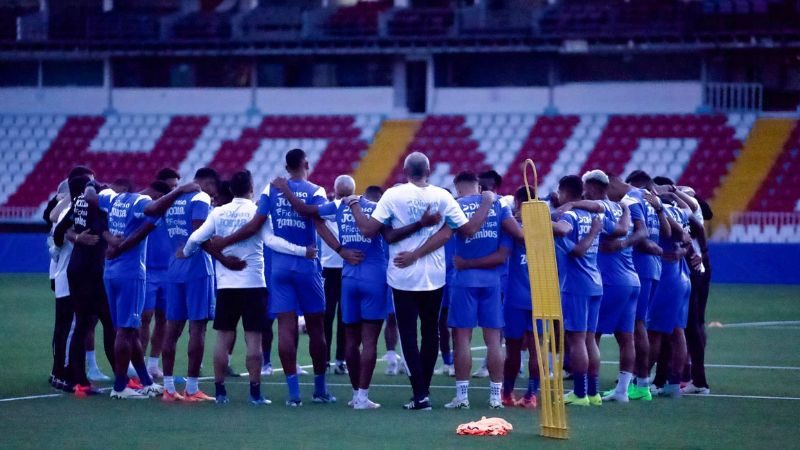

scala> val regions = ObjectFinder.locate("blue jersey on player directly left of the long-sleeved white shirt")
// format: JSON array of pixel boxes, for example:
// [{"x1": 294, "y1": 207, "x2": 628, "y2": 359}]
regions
[{"x1": 164, "y1": 192, "x2": 214, "y2": 283}]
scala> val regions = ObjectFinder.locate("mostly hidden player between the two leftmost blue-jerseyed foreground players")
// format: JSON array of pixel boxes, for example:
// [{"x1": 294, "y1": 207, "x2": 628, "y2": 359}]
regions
[{"x1": 139, "y1": 167, "x2": 180, "y2": 378}]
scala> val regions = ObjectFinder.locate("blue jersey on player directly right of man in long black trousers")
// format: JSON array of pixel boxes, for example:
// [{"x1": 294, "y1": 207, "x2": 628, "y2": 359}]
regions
[{"x1": 453, "y1": 194, "x2": 512, "y2": 287}]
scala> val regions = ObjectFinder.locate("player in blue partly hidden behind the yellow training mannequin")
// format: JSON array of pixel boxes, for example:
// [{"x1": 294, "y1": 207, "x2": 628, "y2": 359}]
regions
[{"x1": 502, "y1": 187, "x2": 539, "y2": 408}]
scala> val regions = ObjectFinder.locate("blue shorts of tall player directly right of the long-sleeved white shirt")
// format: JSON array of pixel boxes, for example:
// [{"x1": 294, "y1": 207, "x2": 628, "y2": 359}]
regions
[{"x1": 269, "y1": 268, "x2": 325, "y2": 314}]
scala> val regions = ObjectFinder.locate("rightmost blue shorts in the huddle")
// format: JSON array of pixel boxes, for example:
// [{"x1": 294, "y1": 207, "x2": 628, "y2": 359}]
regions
[{"x1": 647, "y1": 270, "x2": 690, "y2": 334}]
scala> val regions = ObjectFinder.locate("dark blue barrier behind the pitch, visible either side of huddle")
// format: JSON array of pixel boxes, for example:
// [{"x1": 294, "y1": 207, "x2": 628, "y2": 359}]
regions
[{"x1": 0, "y1": 233, "x2": 800, "y2": 284}]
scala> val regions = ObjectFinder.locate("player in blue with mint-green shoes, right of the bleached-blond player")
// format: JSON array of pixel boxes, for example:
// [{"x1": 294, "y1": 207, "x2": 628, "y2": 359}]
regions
[{"x1": 608, "y1": 170, "x2": 670, "y2": 401}]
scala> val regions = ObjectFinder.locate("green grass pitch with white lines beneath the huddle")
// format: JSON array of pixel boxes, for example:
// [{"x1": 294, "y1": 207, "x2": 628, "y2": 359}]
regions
[{"x1": 0, "y1": 275, "x2": 800, "y2": 449}]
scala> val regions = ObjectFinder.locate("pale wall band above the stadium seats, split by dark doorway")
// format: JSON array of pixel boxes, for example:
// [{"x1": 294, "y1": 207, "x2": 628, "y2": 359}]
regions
[{"x1": 0, "y1": 82, "x2": 702, "y2": 115}]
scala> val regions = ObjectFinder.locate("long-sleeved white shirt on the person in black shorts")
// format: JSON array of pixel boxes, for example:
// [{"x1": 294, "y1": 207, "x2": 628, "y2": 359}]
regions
[{"x1": 183, "y1": 198, "x2": 306, "y2": 289}]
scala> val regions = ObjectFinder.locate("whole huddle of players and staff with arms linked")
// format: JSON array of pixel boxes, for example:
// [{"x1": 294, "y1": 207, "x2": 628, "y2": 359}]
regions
[{"x1": 46, "y1": 149, "x2": 708, "y2": 410}]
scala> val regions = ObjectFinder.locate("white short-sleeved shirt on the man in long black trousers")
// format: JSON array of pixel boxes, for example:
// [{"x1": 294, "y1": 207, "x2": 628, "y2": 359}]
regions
[{"x1": 372, "y1": 183, "x2": 468, "y2": 291}]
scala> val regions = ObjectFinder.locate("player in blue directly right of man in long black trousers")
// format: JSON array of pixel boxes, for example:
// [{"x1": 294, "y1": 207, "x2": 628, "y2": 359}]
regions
[{"x1": 445, "y1": 172, "x2": 516, "y2": 409}]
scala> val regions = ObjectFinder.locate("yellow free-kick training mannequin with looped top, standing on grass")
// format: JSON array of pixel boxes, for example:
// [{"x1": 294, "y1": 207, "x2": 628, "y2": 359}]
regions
[{"x1": 521, "y1": 159, "x2": 569, "y2": 439}]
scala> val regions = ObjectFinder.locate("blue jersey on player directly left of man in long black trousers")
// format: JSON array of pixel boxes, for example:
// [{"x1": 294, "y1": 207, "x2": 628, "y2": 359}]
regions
[{"x1": 319, "y1": 197, "x2": 387, "y2": 283}]
